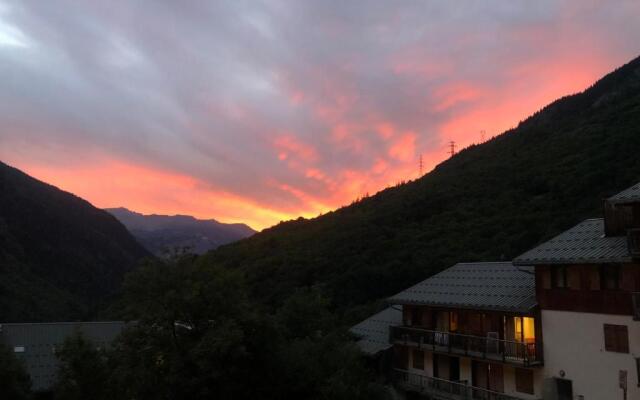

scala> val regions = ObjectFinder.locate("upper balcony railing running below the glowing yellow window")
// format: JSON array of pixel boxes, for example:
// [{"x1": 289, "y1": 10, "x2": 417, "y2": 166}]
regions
[{"x1": 390, "y1": 326, "x2": 542, "y2": 366}]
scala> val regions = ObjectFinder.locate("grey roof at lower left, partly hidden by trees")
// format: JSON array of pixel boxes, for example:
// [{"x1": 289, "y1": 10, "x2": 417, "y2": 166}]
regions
[{"x1": 0, "y1": 321, "x2": 125, "y2": 391}]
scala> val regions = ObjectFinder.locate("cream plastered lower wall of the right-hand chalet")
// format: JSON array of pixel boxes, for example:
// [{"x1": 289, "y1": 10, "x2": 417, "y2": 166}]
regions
[{"x1": 542, "y1": 310, "x2": 640, "y2": 400}]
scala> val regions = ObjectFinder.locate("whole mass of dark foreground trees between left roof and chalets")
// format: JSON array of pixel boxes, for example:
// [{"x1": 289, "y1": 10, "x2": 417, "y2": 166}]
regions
[{"x1": 56, "y1": 255, "x2": 384, "y2": 400}]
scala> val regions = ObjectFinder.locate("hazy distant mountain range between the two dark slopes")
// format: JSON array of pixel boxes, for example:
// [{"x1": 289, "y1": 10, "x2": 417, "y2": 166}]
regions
[{"x1": 106, "y1": 208, "x2": 256, "y2": 255}]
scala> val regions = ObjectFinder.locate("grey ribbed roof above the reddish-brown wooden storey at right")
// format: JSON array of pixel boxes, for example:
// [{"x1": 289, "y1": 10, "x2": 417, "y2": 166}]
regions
[{"x1": 513, "y1": 218, "x2": 631, "y2": 265}]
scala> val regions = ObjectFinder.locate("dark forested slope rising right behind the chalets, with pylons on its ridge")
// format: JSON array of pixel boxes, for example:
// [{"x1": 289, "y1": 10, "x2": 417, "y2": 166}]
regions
[{"x1": 207, "y1": 55, "x2": 640, "y2": 316}]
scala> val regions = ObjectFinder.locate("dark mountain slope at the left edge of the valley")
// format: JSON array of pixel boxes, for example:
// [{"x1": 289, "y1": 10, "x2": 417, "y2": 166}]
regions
[{"x1": 0, "y1": 162, "x2": 151, "y2": 323}]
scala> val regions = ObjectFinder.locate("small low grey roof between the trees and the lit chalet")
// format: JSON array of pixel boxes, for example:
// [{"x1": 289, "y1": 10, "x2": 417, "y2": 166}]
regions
[{"x1": 349, "y1": 307, "x2": 402, "y2": 355}]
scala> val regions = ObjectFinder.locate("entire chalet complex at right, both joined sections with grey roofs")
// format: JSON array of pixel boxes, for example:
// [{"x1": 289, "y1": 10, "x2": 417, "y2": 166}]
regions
[{"x1": 354, "y1": 184, "x2": 640, "y2": 400}]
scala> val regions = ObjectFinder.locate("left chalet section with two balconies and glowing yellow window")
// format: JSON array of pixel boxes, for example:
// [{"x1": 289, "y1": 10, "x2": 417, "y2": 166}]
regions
[{"x1": 361, "y1": 262, "x2": 543, "y2": 400}]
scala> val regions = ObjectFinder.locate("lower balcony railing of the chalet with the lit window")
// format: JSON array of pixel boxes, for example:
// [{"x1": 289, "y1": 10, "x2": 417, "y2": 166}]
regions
[{"x1": 394, "y1": 369, "x2": 536, "y2": 400}]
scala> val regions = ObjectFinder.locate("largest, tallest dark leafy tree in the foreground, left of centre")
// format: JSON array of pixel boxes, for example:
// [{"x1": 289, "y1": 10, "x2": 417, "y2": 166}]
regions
[{"x1": 111, "y1": 254, "x2": 278, "y2": 399}]
